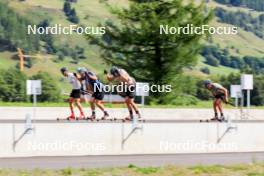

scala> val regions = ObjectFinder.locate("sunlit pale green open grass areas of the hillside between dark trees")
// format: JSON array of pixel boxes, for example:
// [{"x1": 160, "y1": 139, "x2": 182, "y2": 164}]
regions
[{"x1": 0, "y1": 0, "x2": 264, "y2": 84}]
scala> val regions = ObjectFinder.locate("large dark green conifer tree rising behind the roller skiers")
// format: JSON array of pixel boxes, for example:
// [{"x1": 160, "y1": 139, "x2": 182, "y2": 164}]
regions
[{"x1": 89, "y1": 0, "x2": 211, "y2": 102}]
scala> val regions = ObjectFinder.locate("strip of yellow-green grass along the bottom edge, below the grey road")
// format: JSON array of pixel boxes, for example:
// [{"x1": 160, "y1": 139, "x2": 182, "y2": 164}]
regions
[{"x1": 0, "y1": 164, "x2": 264, "y2": 176}]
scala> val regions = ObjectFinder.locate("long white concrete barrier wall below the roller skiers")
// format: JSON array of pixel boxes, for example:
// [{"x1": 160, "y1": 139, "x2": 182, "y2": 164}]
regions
[{"x1": 0, "y1": 122, "x2": 264, "y2": 157}]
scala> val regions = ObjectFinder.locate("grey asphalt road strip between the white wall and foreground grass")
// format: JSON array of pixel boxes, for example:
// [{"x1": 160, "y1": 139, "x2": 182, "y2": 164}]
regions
[{"x1": 0, "y1": 152, "x2": 264, "y2": 169}]
